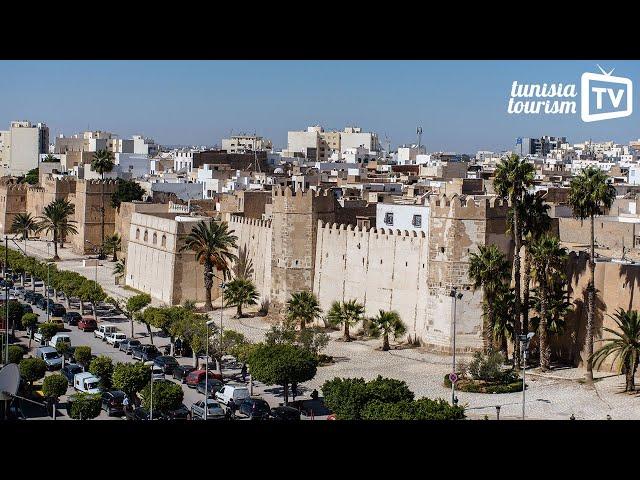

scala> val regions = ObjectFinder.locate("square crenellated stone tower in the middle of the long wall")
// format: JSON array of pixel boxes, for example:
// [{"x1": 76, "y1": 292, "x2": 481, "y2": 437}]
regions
[{"x1": 270, "y1": 187, "x2": 337, "y2": 311}]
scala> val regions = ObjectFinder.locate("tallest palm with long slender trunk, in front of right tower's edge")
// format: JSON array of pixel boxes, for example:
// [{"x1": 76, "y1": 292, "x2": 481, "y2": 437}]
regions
[{"x1": 493, "y1": 154, "x2": 535, "y2": 367}]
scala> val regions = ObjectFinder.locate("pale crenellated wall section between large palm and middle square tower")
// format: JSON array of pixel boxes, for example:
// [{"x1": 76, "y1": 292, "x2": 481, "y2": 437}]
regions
[{"x1": 229, "y1": 215, "x2": 272, "y2": 299}]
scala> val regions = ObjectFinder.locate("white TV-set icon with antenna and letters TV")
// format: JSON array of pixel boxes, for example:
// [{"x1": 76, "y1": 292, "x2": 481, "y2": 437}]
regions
[{"x1": 580, "y1": 65, "x2": 633, "y2": 122}]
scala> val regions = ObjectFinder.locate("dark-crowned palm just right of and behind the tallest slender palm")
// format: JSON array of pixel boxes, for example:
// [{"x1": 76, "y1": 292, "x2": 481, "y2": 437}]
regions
[{"x1": 509, "y1": 193, "x2": 551, "y2": 333}]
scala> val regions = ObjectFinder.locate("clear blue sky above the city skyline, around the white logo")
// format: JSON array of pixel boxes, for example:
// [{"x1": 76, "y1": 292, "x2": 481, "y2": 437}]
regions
[{"x1": 0, "y1": 60, "x2": 640, "y2": 152}]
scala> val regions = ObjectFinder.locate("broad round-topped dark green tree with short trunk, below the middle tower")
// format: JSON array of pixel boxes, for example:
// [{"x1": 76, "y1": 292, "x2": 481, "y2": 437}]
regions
[{"x1": 248, "y1": 344, "x2": 318, "y2": 404}]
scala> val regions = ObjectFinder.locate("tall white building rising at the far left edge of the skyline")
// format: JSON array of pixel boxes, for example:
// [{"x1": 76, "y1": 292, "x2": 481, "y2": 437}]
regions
[{"x1": 0, "y1": 121, "x2": 49, "y2": 176}]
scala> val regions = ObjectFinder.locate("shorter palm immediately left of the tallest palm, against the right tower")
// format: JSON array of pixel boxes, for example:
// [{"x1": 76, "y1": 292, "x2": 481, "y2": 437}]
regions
[{"x1": 469, "y1": 245, "x2": 508, "y2": 353}]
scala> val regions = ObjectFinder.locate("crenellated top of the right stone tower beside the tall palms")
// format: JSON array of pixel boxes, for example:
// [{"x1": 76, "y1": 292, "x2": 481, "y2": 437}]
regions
[{"x1": 429, "y1": 194, "x2": 509, "y2": 219}]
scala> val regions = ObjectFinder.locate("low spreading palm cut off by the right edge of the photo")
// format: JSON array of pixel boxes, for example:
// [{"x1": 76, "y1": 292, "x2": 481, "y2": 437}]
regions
[{"x1": 591, "y1": 308, "x2": 640, "y2": 392}]
